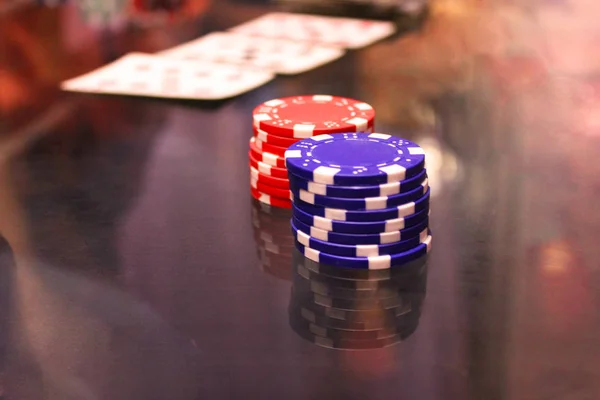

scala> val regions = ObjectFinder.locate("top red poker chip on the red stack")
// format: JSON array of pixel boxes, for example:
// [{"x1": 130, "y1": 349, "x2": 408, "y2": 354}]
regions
[{"x1": 252, "y1": 95, "x2": 375, "y2": 138}]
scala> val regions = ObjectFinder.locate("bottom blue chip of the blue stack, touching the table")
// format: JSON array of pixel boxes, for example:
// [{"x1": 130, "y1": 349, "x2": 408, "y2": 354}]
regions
[{"x1": 296, "y1": 236, "x2": 431, "y2": 269}]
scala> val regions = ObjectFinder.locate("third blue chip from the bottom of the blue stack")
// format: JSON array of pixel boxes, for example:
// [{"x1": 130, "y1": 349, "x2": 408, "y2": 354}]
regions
[{"x1": 292, "y1": 217, "x2": 429, "y2": 246}]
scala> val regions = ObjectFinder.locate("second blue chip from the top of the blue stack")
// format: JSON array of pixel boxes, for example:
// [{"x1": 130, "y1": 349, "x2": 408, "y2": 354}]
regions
[{"x1": 288, "y1": 170, "x2": 427, "y2": 198}]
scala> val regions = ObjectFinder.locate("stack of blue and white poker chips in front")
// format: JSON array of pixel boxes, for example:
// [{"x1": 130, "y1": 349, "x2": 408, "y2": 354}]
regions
[{"x1": 285, "y1": 132, "x2": 432, "y2": 269}]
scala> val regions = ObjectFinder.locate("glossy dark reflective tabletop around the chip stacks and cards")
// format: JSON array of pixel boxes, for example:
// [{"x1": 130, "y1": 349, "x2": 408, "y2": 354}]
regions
[{"x1": 0, "y1": 0, "x2": 600, "y2": 400}]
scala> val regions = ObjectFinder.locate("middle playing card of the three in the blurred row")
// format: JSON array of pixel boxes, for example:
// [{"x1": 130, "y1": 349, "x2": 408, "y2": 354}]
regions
[{"x1": 159, "y1": 32, "x2": 344, "y2": 74}]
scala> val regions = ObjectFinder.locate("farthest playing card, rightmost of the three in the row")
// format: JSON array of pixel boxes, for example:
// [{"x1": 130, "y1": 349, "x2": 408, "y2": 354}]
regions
[{"x1": 231, "y1": 13, "x2": 396, "y2": 49}]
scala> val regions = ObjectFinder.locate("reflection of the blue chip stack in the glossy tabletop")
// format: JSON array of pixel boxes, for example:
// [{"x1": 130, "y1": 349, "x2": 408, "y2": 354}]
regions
[{"x1": 289, "y1": 251, "x2": 427, "y2": 350}]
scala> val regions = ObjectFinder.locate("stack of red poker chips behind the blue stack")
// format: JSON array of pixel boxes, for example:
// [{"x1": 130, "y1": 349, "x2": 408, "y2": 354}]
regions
[{"x1": 248, "y1": 95, "x2": 375, "y2": 208}]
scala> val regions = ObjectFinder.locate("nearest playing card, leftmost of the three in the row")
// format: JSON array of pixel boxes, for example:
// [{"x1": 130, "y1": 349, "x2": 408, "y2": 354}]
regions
[{"x1": 61, "y1": 53, "x2": 274, "y2": 100}]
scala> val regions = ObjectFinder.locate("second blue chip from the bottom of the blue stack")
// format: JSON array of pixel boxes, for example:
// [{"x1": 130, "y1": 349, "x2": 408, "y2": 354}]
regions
[{"x1": 292, "y1": 222, "x2": 430, "y2": 257}]
